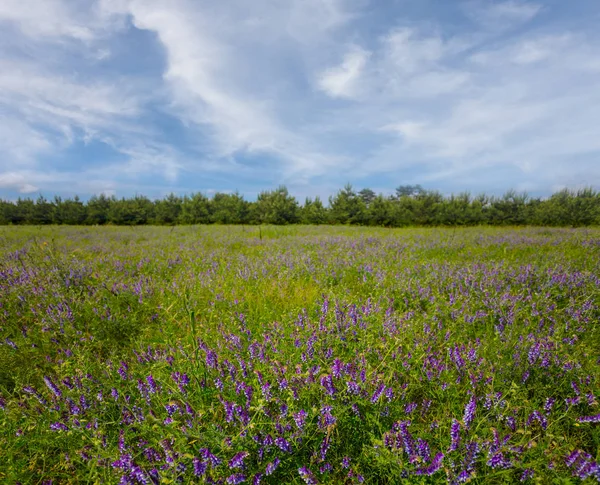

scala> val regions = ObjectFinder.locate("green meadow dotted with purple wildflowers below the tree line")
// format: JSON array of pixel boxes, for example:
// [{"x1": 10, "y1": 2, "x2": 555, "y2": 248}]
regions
[{"x1": 0, "y1": 226, "x2": 600, "y2": 485}]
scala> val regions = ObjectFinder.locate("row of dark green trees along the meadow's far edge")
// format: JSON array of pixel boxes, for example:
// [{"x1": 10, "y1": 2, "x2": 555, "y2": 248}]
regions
[{"x1": 0, "y1": 185, "x2": 600, "y2": 227}]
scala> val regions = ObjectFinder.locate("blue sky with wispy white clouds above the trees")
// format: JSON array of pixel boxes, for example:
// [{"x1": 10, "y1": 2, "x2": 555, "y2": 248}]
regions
[{"x1": 0, "y1": 0, "x2": 600, "y2": 200}]
